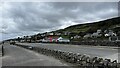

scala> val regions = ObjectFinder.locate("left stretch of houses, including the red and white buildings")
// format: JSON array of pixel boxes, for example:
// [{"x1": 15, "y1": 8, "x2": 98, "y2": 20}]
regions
[{"x1": 16, "y1": 32, "x2": 69, "y2": 42}]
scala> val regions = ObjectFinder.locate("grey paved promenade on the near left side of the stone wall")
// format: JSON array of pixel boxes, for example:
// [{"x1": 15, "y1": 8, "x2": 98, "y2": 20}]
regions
[{"x1": 2, "y1": 44, "x2": 68, "y2": 66}]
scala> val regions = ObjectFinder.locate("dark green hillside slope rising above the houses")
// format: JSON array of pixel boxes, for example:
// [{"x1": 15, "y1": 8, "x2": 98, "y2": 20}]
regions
[{"x1": 55, "y1": 17, "x2": 120, "y2": 34}]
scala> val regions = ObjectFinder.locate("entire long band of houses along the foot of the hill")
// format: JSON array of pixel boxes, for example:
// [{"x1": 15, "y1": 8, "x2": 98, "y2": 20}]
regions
[{"x1": 13, "y1": 29, "x2": 120, "y2": 42}]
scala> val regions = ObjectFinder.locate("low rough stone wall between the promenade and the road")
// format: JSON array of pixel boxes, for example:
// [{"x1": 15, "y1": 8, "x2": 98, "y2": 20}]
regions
[{"x1": 16, "y1": 44, "x2": 119, "y2": 68}]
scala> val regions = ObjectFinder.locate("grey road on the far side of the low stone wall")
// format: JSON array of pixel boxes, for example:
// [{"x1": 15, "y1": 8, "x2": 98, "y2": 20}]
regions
[{"x1": 19, "y1": 43, "x2": 120, "y2": 62}]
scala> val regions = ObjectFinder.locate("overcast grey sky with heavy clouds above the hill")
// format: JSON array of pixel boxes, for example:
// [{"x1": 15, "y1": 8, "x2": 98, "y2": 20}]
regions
[{"x1": 0, "y1": 2, "x2": 118, "y2": 40}]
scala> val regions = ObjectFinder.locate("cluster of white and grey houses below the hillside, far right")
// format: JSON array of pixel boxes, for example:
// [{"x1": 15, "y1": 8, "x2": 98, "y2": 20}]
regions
[{"x1": 83, "y1": 30, "x2": 120, "y2": 41}]
